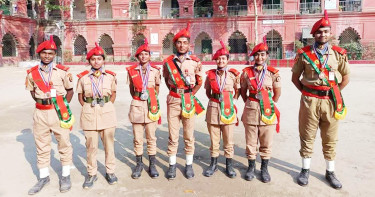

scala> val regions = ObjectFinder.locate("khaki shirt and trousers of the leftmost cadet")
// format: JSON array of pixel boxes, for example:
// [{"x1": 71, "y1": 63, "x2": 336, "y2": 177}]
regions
[{"x1": 25, "y1": 64, "x2": 73, "y2": 169}]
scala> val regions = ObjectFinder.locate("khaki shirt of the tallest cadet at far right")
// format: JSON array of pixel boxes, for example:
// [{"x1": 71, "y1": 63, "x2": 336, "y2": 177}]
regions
[{"x1": 292, "y1": 46, "x2": 350, "y2": 86}]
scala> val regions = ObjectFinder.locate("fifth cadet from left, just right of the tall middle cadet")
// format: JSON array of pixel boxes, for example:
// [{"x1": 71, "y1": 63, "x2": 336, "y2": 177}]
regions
[{"x1": 203, "y1": 41, "x2": 241, "y2": 178}]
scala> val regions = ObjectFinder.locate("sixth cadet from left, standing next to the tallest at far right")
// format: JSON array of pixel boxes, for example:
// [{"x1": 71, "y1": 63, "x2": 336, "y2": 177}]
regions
[{"x1": 241, "y1": 40, "x2": 281, "y2": 183}]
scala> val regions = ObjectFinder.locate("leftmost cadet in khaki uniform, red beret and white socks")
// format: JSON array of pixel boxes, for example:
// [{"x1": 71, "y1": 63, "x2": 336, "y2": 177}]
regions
[{"x1": 26, "y1": 36, "x2": 74, "y2": 195}]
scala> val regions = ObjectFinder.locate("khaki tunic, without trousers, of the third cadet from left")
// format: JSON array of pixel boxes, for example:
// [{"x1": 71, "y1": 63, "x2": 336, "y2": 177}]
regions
[{"x1": 128, "y1": 67, "x2": 161, "y2": 123}]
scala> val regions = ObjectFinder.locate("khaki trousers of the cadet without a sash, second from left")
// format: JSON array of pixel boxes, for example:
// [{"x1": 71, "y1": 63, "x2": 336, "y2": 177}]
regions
[{"x1": 84, "y1": 127, "x2": 116, "y2": 176}]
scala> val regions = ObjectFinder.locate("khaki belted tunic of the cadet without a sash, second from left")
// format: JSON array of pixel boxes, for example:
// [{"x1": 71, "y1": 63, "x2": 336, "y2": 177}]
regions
[{"x1": 77, "y1": 71, "x2": 117, "y2": 130}]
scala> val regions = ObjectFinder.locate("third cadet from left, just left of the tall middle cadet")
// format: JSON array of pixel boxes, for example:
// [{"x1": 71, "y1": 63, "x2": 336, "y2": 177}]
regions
[{"x1": 126, "y1": 39, "x2": 161, "y2": 179}]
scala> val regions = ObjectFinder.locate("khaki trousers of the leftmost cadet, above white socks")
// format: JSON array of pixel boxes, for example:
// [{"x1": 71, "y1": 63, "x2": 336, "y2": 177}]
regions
[{"x1": 33, "y1": 109, "x2": 73, "y2": 169}]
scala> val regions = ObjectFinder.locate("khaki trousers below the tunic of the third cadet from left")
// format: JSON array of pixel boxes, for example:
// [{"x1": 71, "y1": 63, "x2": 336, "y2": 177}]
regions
[{"x1": 133, "y1": 122, "x2": 157, "y2": 156}]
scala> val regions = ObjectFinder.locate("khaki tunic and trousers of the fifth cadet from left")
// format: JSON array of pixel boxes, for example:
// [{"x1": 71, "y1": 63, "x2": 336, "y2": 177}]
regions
[{"x1": 204, "y1": 71, "x2": 241, "y2": 158}]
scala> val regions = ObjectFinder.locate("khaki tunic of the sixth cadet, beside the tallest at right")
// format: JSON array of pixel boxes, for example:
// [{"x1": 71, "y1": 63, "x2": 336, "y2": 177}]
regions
[{"x1": 241, "y1": 67, "x2": 281, "y2": 125}]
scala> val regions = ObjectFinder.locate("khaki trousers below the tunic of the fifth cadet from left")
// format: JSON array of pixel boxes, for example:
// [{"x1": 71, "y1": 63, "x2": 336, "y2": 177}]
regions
[{"x1": 207, "y1": 123, "x2": 234, "y2": 158}]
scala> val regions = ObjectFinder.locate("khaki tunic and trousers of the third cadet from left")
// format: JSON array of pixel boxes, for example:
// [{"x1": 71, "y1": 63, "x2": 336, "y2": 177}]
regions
[{"x1": 128, "y1": 67, "x2": 161, "y2": 155}]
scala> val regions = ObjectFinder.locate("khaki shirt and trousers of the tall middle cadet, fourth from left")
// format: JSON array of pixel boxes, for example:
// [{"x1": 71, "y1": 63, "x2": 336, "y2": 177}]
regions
[{"x1": 163, "y1": 55, "x2": 203, "y2": 156}]
